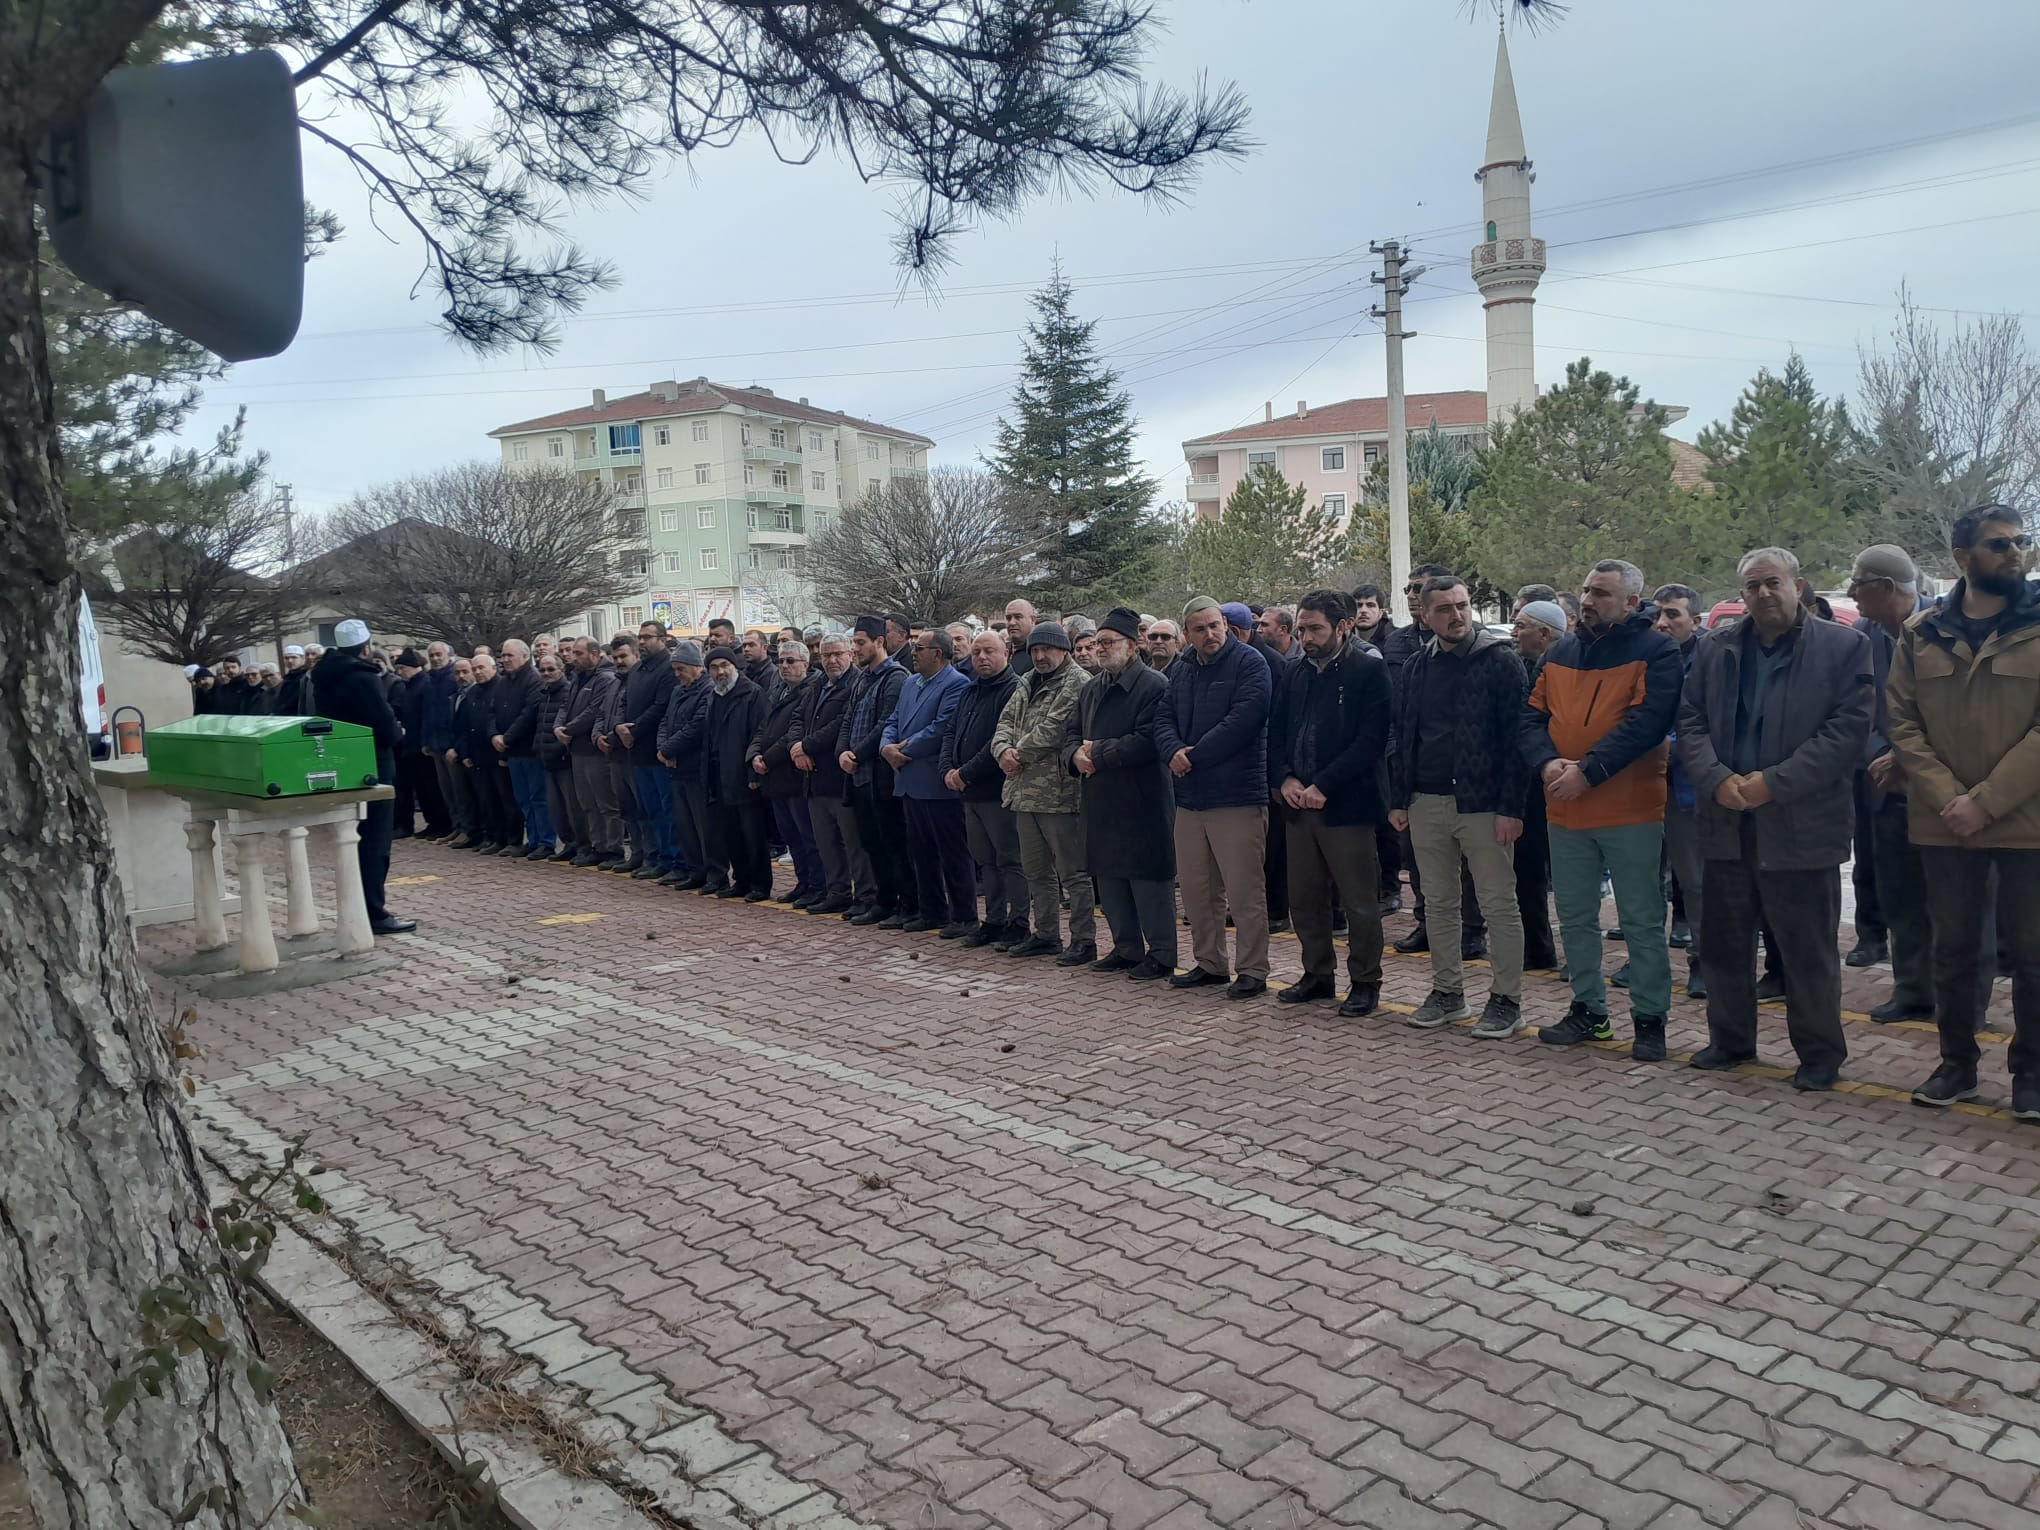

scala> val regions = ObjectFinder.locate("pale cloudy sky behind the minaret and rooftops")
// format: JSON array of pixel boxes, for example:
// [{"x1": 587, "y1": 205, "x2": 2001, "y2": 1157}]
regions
[{"x1": 179, "y1": 0, "x2": 2040, "y2": 510}]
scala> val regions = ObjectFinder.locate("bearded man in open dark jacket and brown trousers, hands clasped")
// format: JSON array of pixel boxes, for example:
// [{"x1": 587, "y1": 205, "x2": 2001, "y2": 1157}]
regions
[{"x1": 1269, "y1": 590, "x2": 1391, "y2": 1018}]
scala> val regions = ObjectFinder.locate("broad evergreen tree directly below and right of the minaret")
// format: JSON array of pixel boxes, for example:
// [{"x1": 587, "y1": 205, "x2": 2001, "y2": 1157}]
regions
[{"x1": 1467, "y1": 357, "x2": 1710, "y2": 590}]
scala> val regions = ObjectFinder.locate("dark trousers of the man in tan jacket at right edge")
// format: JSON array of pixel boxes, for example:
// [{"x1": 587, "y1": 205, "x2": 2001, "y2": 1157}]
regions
[{"x1": 1920, "y1": 845, "x2": 2040, "y2": 1079}]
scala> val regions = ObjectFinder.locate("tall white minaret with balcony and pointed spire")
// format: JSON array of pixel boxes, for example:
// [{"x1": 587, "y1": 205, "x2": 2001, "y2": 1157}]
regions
[{"x1": 1473, "y1": 24, "x2": 1544, "y2": 422}]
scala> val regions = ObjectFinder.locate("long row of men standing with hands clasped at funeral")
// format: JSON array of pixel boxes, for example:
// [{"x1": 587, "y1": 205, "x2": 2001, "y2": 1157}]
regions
[{"x1": 295, "y1": 506, "x2": 2040, "y2": 1122}]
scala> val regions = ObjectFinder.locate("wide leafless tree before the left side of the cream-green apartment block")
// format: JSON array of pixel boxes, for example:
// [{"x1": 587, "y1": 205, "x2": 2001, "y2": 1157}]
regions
[{"x1": 294, "y1": 463, "x2": 645, "y2": 649}]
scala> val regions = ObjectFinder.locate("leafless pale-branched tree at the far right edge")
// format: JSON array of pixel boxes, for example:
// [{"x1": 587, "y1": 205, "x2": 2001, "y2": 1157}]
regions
[{"x1": 1850, "y1": 288, "x2": 2040, "y2": 573}]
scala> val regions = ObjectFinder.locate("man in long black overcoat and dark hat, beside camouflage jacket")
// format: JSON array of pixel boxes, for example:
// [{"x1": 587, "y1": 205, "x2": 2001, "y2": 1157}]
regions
[{"x1": 1065, "y1": 606, "x2": 1177, "y2": 983}]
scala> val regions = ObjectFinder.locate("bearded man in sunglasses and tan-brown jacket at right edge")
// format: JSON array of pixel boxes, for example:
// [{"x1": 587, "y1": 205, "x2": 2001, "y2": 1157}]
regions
[{"x1": 1887, "y1": 504, "x2": 2040, "y2": 1122}]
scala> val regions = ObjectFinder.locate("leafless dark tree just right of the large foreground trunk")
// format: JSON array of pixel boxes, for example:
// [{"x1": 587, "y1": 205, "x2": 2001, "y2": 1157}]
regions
[{"x1": 86, "y1": 494, "x2": 298, "y2": 665}]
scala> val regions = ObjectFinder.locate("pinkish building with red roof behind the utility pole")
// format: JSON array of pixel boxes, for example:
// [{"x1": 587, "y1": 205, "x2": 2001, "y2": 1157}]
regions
[{"x1": 1183, "y1": 392, "x2": 1487, "y2": 520}]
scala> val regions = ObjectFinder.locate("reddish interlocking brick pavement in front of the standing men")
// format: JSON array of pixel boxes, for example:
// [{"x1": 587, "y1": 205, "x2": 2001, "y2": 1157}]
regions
[{"x1": 145, "y1": 847, "x2": 2040, "y2": 1530}]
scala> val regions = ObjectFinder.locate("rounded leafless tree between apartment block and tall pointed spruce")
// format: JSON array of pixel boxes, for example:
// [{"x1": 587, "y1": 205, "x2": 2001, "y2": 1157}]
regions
[{"x1": 808, "y1": 467, "x2": 1055, "y2": 622}]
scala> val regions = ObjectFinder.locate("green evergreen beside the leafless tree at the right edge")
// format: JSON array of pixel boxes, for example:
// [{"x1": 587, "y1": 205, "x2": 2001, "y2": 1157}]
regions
[{"x1": 1699, "y1": 353, "x2": 1863, "y2": 569}]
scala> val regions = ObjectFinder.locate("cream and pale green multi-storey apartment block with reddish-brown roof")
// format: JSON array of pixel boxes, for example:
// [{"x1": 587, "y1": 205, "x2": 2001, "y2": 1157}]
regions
[{"x1": 490, "y1": 377, "x2": 934, "y2": 632}]
